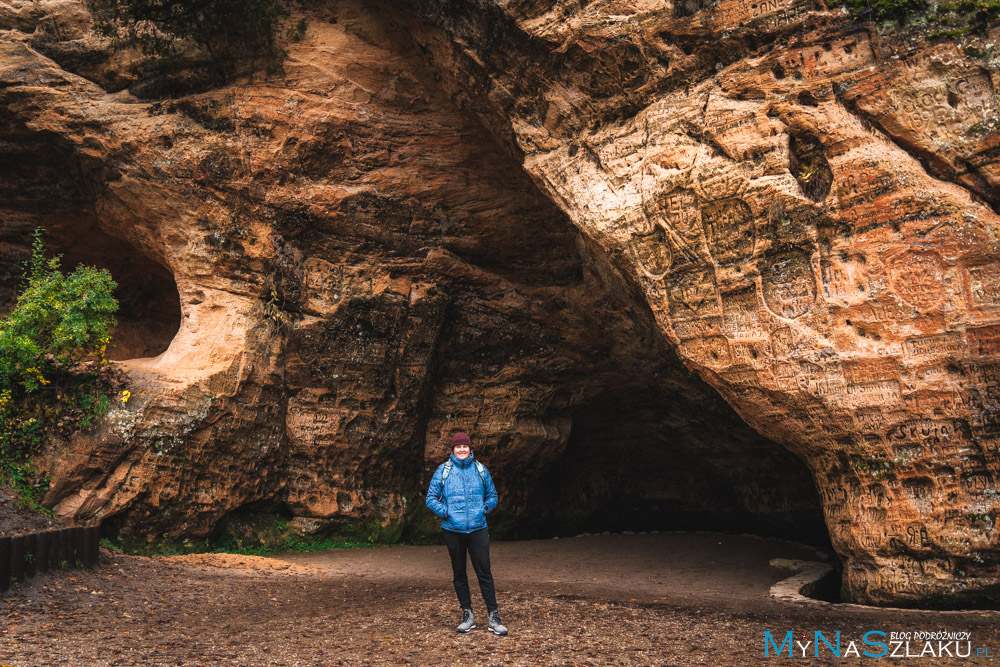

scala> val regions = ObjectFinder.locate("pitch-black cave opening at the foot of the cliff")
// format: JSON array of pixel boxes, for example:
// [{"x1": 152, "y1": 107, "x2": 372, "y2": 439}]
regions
[{"x1": 512, "y1": 375, "x2": 832, "y2": 553}]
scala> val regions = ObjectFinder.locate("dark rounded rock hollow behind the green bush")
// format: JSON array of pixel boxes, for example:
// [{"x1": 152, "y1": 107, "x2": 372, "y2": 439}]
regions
[{"x1": 0, "y1": 114, "x2": 181, "y2": 360}]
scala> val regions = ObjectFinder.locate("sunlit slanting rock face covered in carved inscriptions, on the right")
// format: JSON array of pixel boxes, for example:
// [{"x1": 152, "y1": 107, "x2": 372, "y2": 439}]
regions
[{"x1": 388, "y1": 0, "x2": 1000, "y2": 604}]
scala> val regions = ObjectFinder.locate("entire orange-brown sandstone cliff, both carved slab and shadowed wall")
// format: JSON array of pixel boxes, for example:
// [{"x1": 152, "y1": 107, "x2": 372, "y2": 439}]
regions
[{"x1": 0, "y1": 0, "x2": 1000, "y2": 604}]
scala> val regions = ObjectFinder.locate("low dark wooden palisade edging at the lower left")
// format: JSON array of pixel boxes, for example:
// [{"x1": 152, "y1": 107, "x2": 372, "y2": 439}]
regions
[{"x1": 0, "y1": 526, "x2": 101, "y2": 591}]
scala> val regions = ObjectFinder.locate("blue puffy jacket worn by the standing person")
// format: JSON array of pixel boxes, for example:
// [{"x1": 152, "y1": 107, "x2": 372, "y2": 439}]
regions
[{"x1": 427, "y1": 452, "x2": 497, "y2": 533}]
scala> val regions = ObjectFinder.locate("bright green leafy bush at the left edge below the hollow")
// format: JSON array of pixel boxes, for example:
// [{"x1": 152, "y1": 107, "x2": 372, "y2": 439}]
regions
[{"x1": 0, "y1": 230, "x2": 118, "y2": 509}]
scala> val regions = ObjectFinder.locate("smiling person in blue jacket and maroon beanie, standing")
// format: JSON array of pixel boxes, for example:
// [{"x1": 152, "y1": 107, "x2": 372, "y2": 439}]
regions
[{"x1": 427, "y1": 433, "x2": 507, "y2": 635}]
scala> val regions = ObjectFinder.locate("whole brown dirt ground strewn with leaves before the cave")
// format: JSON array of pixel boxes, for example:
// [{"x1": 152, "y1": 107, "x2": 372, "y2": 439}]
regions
[{"x1": 0, "y1": 533, "x2": 1000, "y2": 666}]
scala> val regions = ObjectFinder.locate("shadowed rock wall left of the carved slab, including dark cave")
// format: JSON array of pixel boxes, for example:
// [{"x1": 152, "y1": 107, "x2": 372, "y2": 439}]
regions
[{"x1": 0, "y1": 0, "x2": 822, "y2": 568}]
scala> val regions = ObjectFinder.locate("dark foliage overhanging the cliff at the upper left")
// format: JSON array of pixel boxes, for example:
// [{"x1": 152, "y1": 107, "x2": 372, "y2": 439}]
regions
[{"x1": 87, "y1": 0, "x2": 292, "y2": 75}]
